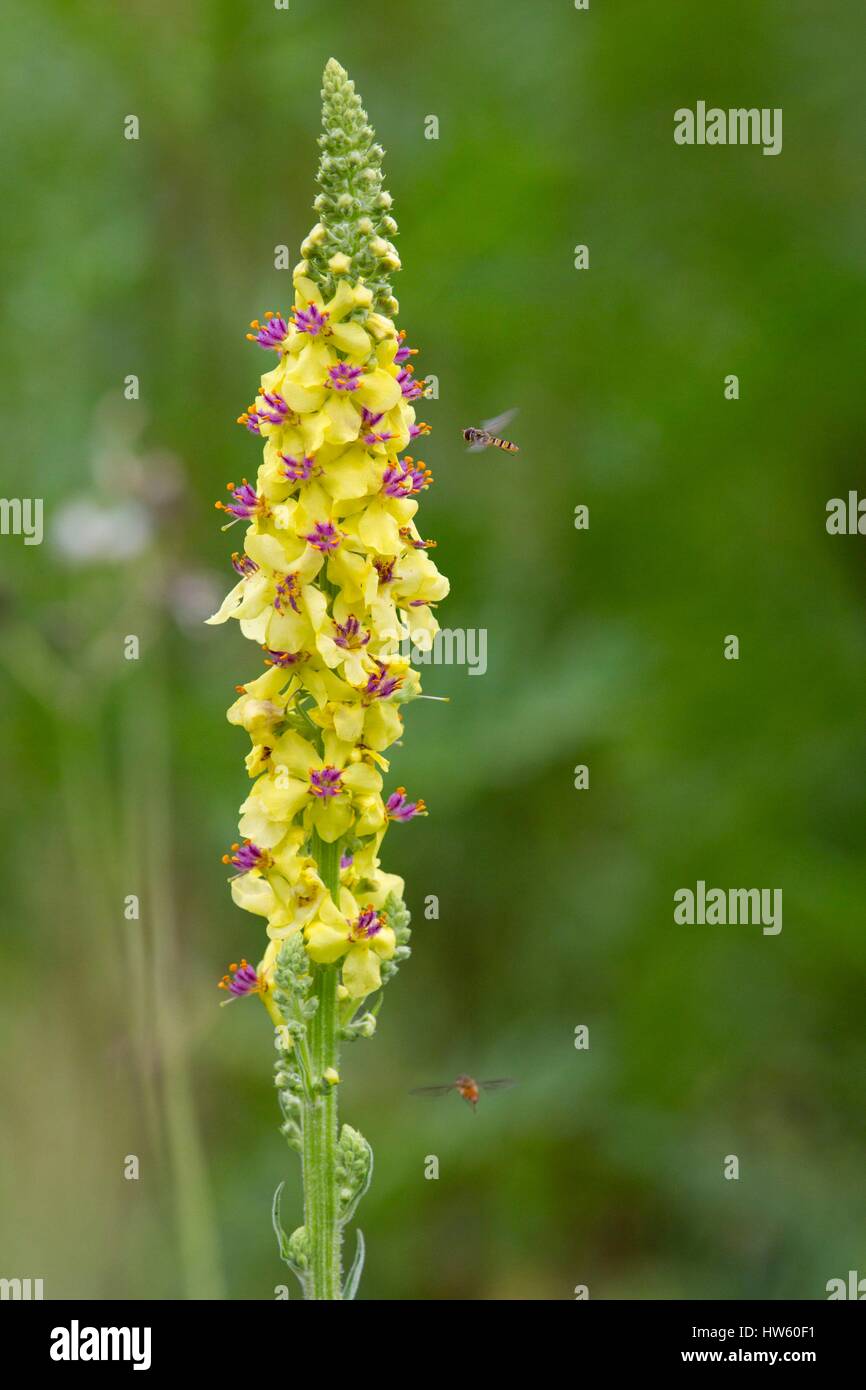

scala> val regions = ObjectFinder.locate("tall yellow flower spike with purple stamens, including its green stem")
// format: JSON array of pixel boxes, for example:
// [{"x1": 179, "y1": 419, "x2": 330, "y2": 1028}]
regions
[{"x1": 210, "y1": 60, "x2": 448, "y2": 1300}]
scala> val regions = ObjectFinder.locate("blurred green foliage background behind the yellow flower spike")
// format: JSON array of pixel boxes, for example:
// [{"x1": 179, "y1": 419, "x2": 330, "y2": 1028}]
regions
[{"x1": 0, "y1": 0, "x2": 866, "y2": 1300}]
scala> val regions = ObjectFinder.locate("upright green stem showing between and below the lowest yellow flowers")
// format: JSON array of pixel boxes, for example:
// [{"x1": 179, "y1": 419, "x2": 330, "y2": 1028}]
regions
[{"x1": 303, "y1": 835, "x2": 342, "y2": 1301}]
